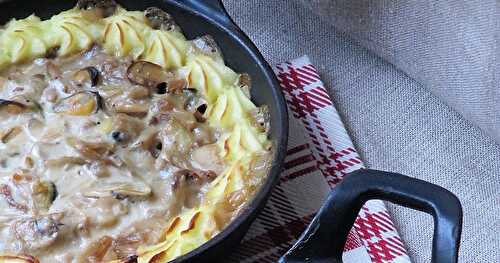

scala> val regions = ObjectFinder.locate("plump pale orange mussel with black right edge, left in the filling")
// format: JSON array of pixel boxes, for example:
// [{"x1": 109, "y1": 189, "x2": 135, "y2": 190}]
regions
[{"x1": 53, "y1": 91, "x2": 102, "y2": 116}]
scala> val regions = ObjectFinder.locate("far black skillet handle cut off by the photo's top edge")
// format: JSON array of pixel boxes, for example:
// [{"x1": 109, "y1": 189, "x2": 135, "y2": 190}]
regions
[{"x1": 179, "y1": 0, "x2": 239, "y2": 31}]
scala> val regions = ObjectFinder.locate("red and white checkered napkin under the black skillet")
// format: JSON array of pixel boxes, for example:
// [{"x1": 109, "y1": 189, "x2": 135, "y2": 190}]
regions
[{"x1": 230, "y1": 57, "x2": 410, "y2": 263}]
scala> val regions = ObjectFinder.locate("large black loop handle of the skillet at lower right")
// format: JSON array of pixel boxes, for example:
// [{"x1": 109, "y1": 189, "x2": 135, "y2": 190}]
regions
[{"x1": 279, "y1": 169, "x2": 462, "y2": 263}]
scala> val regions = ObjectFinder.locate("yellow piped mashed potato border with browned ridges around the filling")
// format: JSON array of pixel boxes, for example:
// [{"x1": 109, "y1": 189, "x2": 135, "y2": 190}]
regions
[{"x1": 0, "y1": 4, "x2": 271, "y2": 263}]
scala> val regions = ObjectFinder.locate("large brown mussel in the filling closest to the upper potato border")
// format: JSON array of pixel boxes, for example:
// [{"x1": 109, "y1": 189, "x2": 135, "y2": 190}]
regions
[{"x1": 127, "y1": 61, "x2": 173, "y2": 88}]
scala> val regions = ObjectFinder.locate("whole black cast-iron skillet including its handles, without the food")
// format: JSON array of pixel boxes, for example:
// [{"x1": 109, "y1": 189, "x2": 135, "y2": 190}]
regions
[{"x1": 0, "y1": 0, "x2": 462, "y2": 263}]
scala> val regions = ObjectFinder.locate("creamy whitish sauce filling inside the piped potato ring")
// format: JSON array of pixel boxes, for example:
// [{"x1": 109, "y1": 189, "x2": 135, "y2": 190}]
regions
[{"x1": 0, "y1": 48, "x2": 223, "y2": 262}]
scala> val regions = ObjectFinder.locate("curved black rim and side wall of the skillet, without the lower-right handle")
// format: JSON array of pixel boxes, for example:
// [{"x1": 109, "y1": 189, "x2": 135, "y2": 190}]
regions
[{"x1": 0, "y1": 0, "x2": 288, "y2": 263}]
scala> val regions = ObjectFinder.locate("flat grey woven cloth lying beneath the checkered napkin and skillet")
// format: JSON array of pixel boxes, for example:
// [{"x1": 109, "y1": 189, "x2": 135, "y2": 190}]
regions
[{"x1": 224, "y1": 0, "x2": 500, "y2": 262}]
